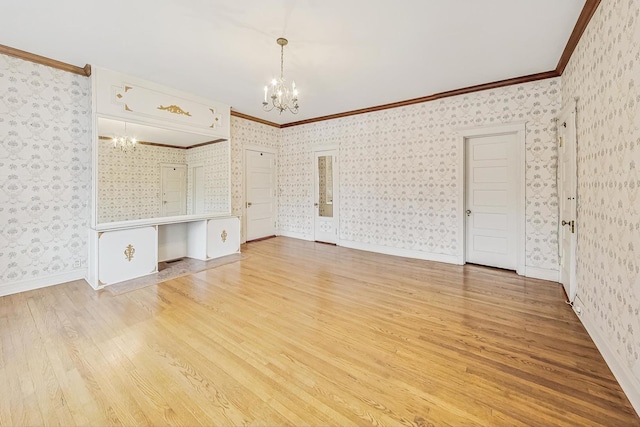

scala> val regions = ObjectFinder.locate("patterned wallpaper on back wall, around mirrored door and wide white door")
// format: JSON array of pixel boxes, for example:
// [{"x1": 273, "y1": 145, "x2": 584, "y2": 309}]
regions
[{"x1": 279, "y1": 79, "x2": 561, "y2": 270}]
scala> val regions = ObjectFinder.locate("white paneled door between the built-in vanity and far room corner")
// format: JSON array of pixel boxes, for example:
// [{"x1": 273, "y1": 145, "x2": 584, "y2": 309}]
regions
[{"x1": 245, "y1": 150, "x2": 276, "y2": 241}]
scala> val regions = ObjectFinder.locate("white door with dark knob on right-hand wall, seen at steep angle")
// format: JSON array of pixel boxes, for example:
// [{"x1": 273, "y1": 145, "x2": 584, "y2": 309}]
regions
[{"x1": 558, "y1": 102, "x2": 578, "y2": 301}]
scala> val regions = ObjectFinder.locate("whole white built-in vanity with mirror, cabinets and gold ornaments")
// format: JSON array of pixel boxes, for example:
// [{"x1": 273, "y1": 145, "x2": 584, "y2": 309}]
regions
[{"x1": 88, "y1": 68, "x2": 240, "y2": 289}]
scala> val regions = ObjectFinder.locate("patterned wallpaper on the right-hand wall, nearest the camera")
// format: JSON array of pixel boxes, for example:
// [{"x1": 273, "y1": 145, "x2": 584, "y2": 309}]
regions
[{"x1": 562, "y1": 0, "x2": 640, "y2": 383}]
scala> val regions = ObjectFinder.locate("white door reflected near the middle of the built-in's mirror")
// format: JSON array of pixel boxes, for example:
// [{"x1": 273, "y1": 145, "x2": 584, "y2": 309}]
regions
[{"x1": 160, "y1": 163, "x2": 187, "y2": 216}]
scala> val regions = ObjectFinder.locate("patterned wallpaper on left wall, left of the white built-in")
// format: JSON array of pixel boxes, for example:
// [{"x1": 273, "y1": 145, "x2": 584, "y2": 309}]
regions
[{"x1": 0, "y1": 55, "x2": 91, "y2": 284}]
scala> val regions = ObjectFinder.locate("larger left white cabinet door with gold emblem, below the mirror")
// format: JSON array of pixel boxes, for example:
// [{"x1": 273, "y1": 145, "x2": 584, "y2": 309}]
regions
[{"x1": 98, "y1": 227, "x2": 158, "y2": 285}]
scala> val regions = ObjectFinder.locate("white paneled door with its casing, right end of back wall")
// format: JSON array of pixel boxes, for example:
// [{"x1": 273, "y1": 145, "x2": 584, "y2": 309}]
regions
[{"x1": 457, "y1": 123, "x2": 526, "y2": 275}]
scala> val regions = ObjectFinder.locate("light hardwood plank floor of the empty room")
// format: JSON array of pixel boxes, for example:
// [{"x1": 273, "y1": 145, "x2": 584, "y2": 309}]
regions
[{"x1": 0, "y1": 238, "x2": 640, "y2": 426}]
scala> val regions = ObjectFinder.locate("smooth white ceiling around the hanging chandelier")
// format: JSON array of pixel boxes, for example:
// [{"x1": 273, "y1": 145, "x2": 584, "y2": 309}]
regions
[{"x1": 0, "y1": 0, "x2": 585, "y2": 123}]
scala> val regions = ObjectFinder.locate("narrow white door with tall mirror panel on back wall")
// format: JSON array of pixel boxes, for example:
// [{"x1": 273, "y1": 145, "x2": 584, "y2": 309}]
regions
[{"x1": 313, "y1": 149, "x2": 340, "y2": 243}]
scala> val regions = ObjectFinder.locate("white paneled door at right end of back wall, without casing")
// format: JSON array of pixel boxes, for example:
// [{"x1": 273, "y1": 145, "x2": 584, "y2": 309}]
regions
[{"x1": 465, "y1": 133, "x2": 518, "y2": 270}]
